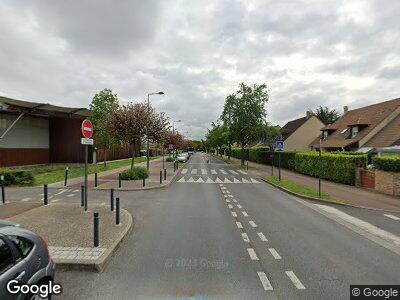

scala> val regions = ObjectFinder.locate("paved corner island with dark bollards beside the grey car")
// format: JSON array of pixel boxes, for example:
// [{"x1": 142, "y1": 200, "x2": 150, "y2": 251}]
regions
[{"x1": 8, "y1": 203, "x2": 133, "y2": 272}]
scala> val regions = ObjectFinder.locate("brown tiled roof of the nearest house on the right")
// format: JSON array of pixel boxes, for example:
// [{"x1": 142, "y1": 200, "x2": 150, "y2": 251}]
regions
[{"x1": 311, "y1": 98, "x2": 400, "y2": 148}]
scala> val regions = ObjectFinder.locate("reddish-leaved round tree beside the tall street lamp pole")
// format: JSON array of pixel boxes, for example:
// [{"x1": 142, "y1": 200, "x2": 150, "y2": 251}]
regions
[{"x1": 107, "y1": 102, "x2": 152, "y2": 169}]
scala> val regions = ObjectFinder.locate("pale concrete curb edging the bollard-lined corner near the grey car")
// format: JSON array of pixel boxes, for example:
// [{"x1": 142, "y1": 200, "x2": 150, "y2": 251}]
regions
[{"x1": 55, "y1": 209, "x2": 133, "y2": 272}]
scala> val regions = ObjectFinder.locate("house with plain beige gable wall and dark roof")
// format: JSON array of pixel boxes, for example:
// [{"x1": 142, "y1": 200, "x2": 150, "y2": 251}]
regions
[{"x1": 281, "y1": 111, "x2": 325, "y2": 151}]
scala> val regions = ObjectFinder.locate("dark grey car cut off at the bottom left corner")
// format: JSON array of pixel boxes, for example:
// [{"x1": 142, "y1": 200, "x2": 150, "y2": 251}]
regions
[{"x1": 0, "y1": 221, "x2": 55, "y2": 299}]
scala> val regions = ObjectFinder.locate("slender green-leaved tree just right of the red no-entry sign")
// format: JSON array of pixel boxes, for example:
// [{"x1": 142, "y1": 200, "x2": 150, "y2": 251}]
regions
[{"x1": 90, "y1": 89, "x2": 118, "y2": 165}]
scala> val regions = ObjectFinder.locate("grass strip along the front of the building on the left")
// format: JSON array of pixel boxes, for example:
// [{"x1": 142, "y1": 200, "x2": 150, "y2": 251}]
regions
[{"x1": 5, "y1": 157, "x2": 157, "y2": 186}]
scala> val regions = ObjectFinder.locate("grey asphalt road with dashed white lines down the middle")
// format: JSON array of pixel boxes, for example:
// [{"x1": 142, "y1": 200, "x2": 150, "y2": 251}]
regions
[{"x1": 3, "y1": 154, "x2": 400, "y2": 299}]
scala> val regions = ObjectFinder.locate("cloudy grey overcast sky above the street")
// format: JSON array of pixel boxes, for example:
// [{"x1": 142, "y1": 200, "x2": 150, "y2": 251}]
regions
[{"x1": 0, "y1": 0, "x2": 400, "y2": 138}]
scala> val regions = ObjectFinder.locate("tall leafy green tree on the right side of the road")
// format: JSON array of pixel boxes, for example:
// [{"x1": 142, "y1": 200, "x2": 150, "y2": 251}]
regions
[{"x1": 221, "y1": 83, "x2": 268, "y2": 165}]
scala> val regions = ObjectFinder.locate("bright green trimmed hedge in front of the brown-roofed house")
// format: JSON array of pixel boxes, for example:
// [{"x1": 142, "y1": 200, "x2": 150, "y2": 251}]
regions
[{"x1": 294, "y1": 152, "x2": 367, "y2": 185}]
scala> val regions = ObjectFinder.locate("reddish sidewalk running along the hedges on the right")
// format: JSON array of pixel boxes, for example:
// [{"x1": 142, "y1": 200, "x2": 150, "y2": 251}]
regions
[{"x1": 220, "y1": 156, "x2": 400, "y2": 212}]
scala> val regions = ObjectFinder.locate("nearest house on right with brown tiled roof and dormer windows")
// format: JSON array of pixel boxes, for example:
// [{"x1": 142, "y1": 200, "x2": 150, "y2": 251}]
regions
[{"x1": 311, "y1": 98, "x2": 400, "y2": 151}]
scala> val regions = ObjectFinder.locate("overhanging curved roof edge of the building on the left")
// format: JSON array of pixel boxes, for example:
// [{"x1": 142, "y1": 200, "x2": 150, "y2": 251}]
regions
[{"x1": 0, "y1": 96, "x2": 91, "y2": 117}]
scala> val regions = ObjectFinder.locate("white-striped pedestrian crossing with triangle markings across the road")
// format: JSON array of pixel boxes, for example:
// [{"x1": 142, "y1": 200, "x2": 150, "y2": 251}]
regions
[{"x1": 177, "y1": 168, "x2": 260, "y2": 184}]
